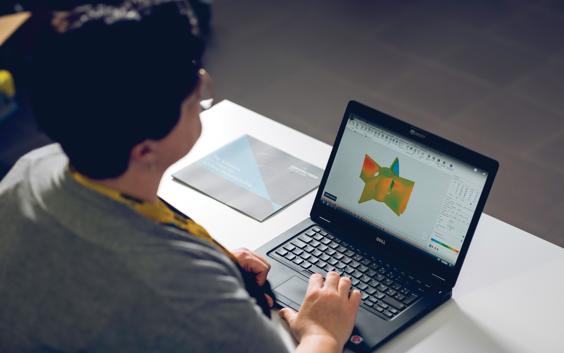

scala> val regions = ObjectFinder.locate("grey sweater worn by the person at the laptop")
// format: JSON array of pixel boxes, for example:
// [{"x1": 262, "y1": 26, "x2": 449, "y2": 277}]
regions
[{"x1": 0, "y1": 144, "x2": 286, "y2": 353}]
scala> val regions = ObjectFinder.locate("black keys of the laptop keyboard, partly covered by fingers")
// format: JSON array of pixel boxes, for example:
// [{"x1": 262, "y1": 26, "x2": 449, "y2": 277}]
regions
[{"x1": 269, "y1": 226, "x2": 429, "y2": 319}]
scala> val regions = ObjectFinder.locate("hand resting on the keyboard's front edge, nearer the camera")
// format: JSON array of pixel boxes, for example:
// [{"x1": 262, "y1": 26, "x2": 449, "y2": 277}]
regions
[{"x1": 280, "y1": 272, "x2": 360, "y2": 351}]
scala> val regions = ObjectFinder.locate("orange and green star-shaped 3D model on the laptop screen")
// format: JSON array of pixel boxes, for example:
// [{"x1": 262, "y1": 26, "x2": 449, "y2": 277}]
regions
[{"x1": 358, "y1": 154, "x2": 415, "y2": 216}]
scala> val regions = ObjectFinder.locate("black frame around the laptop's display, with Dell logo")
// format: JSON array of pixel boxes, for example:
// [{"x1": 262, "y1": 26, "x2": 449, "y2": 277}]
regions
[{"x1": 310, "y1": 101, "x2": 499, "y2": 288}]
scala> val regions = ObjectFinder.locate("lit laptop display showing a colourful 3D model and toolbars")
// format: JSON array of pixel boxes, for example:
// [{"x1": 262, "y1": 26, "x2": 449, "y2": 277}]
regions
[{"x1": 321, "y1": 114, "x2": 488, "y2": 266}]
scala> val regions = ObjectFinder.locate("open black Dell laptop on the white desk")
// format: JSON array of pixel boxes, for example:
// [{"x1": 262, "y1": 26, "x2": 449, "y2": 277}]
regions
[{"x1": 258, "y1": 101, "x2": 499, "y2": 352}]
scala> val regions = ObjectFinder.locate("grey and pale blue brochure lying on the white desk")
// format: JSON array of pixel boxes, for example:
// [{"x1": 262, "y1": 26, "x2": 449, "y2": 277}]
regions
[{"x1": 173, "y1": 135, "x2": 323, "y2": 222}]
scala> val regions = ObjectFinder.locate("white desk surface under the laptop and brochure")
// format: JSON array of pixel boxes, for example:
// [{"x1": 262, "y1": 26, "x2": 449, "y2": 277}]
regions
[{"x1": 159, "y1": 101, "x2": 564, "y2": 353}]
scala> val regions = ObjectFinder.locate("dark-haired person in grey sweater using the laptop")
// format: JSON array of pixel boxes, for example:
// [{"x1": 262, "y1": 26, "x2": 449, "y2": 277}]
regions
[{"x1": 0, "y1": 0, "x2": 360, "y2": 352}]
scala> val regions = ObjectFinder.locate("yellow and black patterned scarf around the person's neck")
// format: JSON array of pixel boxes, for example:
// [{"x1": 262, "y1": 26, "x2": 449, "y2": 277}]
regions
[{"x1": 69, "y1": 168, "x2": 238, "y2": 263}]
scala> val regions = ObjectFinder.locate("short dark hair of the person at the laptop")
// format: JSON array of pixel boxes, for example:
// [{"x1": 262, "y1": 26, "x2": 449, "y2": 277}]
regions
[{"x1": 32, "y1": 0, "x2": 204, "y2": 179}]
